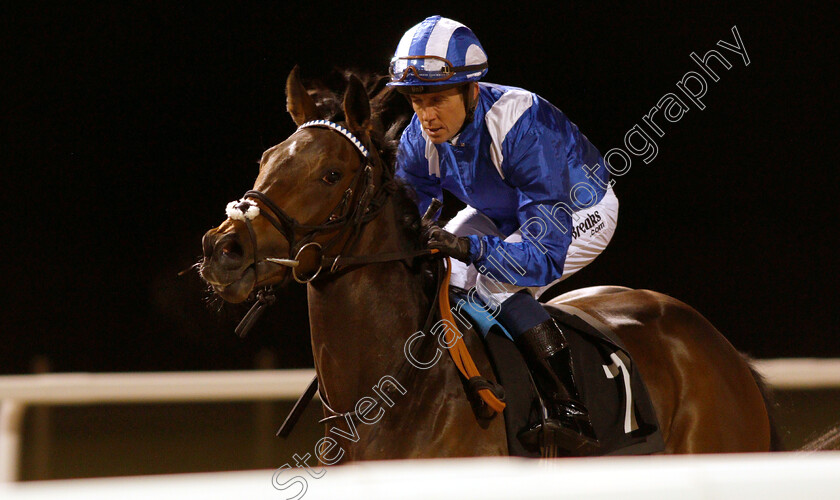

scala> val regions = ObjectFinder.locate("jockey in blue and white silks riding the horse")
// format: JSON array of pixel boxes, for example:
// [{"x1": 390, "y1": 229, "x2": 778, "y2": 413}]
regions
[{"x1": 389, "y1": 16, "x2": 618, "y2": 453}]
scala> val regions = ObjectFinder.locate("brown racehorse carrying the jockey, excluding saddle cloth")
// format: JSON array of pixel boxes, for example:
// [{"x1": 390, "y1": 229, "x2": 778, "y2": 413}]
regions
[{"x1": 200, "y1": 68, "x2": 779, "y2": 461}]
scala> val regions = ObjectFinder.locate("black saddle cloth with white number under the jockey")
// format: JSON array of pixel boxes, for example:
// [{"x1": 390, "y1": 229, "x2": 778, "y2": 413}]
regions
[{"x1": 451, "y1": 291, "x2": 665, "y2": 457}]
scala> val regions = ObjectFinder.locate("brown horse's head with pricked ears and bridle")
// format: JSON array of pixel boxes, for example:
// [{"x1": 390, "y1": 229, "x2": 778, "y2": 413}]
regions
[{"x1": 200, "y1": 67, "x2": 384, "y2": 302}]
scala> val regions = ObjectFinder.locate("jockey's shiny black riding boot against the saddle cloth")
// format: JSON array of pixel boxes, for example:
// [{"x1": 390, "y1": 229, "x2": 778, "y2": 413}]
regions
[{"x1": 516, "y1": 319, "x2": 600, "y2": 456}]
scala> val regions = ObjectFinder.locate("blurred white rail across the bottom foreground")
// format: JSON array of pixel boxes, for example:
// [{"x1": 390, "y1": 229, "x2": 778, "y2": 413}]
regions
[{"x1": 0, "y1": 452, "x2": 840, "y2": 500}]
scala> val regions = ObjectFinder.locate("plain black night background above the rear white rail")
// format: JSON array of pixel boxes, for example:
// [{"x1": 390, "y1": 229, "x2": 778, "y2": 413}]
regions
[{"x1": 0, "y1": 1, "x2": 840, "y2": 373}]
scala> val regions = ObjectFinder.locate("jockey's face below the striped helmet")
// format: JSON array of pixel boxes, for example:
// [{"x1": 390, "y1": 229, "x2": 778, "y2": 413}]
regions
[{"x1": 410, "y1": 88, "x2": 467, "y2": 144}]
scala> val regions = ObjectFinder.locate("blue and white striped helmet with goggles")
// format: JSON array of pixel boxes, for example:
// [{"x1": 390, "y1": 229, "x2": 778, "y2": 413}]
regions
[{"x1": 388, "y1": 16, "x2": 487, "y2": 93}]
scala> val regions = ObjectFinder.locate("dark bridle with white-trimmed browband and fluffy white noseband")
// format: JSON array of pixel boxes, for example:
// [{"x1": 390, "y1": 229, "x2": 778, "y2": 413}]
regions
[{"x1": 226, "y1": 120, "x2": 433, "y2": 337}]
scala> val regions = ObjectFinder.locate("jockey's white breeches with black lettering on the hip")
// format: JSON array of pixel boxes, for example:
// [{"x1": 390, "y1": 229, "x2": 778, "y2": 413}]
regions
[{"x1": 444, "y1": 187, "x2": 618, "y2": 306}]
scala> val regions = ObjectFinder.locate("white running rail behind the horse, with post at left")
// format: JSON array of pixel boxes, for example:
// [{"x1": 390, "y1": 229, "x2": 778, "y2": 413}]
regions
[{"x1": 0, "y1": 359, "x2": 840, "y2": 482}]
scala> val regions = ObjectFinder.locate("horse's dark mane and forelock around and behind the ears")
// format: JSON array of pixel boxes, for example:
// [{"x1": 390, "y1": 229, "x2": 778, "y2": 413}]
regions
[{"x1": 304, "y1": 69, "x2": 421, "y2": 245}]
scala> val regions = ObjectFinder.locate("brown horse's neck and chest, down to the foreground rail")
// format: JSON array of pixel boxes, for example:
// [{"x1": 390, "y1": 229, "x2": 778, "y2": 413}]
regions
[{"x1": 309, "y1": 192, "x2": 507, "y2": 460}]
